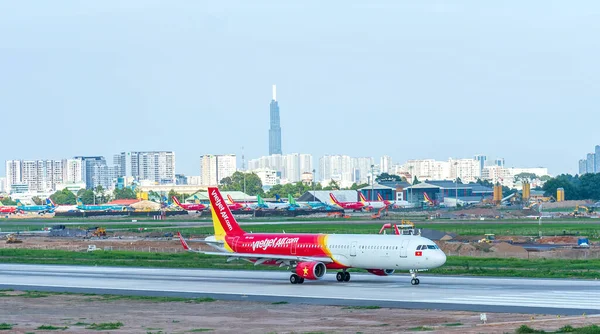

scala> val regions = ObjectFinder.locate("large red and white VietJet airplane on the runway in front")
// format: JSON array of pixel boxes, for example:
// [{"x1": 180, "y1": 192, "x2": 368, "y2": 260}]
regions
[{"x1": 178, "y1": 187, "x2": 446, "y2": 285}]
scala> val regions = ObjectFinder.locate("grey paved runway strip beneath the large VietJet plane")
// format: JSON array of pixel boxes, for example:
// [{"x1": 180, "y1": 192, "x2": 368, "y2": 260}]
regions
[{"x1": 0, "y1": 264, "x2": 600, "y2": 315}]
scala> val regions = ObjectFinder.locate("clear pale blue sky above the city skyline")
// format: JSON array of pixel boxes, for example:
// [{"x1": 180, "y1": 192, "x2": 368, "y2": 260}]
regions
[{"x1": 0, "y1": 0, "x2": 600, "y2": 175}]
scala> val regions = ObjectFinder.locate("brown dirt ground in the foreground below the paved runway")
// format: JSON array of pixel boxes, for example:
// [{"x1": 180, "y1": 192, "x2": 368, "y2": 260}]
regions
[{"x1": 0, "y1": 291, "x2": 600, "y2": 334}]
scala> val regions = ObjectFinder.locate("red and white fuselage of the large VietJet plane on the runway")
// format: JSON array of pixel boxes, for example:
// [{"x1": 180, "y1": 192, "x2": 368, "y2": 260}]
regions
[{"x1": 215, "y1": 233, "x2": 446, "y2": 270}]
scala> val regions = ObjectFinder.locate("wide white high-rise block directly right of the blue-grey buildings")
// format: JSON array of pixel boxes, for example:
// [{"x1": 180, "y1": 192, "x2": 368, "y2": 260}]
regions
[{"x1": 114, "y1": 151, "x2": 175, "y2": 184}]
